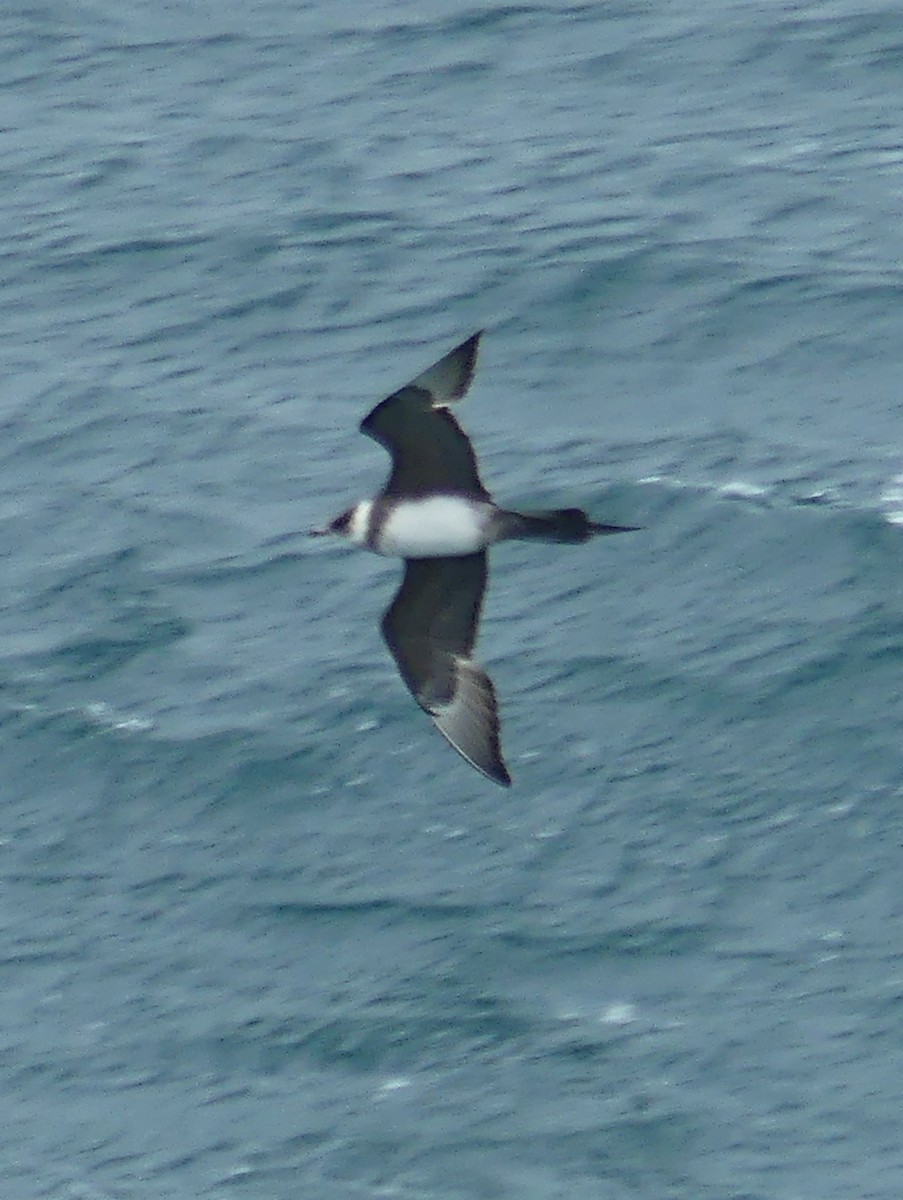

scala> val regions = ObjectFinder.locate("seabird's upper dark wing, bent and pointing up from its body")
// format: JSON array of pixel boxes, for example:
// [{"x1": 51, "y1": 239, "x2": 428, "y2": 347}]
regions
[{"x1": 360, "y1": 334, "x2": 489, "y2": 499}]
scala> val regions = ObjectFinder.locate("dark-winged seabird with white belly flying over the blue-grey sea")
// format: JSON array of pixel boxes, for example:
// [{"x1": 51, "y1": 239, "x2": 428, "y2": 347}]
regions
[{"x1": 311, "y1": 332, "x2": 635, "y2": 787}]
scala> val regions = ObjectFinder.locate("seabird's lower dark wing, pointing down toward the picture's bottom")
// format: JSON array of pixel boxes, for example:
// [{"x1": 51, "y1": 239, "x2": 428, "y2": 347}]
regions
[{"x1": 382, "y1": 552, "x2": 512, "y2": 787}]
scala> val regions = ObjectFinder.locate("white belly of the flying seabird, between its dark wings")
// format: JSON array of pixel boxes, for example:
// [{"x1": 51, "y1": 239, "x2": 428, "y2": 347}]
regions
[{"x1": 376, "y1": 496, "x2": 495, "y2": 558}]
